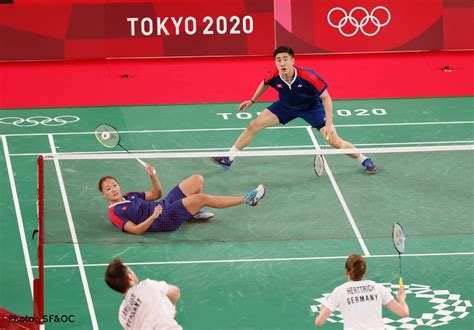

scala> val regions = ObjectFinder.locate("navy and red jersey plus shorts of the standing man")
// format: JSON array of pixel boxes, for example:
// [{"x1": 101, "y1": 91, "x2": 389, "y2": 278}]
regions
[{"x1": 263, "y1": 67, "x2": 328, "y2": 129}]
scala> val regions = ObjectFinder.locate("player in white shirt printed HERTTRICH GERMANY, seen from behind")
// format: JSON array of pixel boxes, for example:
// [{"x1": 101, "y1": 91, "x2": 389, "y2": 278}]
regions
[{"x1": 315, "y1": 254, "x2": 409, "y2": 330}]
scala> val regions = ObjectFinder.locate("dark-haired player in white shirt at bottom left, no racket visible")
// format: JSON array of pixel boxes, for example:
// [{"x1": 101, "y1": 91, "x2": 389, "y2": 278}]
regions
[{"x1": 105, "y1": 259, "x2": 183, "y2": 330}]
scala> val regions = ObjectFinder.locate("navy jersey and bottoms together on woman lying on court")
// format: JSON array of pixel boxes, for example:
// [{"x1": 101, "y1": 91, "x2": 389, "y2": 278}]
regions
[{"x1": 109, "y1": 186, "x2": 193, "y2": 232}]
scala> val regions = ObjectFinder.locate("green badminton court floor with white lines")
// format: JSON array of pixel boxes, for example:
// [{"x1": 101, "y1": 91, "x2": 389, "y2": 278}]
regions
[{"x1": 0, "y1": 97, "x2": 474, "y2": 329}]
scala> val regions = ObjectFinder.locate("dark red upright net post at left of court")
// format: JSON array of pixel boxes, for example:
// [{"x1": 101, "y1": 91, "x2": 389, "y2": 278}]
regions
[{"x1": 33, "y1": 155, "x2": 44, "y2": 327}]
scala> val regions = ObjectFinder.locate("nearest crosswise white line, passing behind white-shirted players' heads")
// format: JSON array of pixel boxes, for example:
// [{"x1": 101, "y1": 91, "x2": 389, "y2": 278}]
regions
[{"x1": 33, "y1": 252, "x2": 474, "y2": 268}]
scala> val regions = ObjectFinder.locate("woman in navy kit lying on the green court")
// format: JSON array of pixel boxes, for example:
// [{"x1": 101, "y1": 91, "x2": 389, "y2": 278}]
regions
[{"x1": 99, "y1": 164, "x2": 265, "y2": 235}]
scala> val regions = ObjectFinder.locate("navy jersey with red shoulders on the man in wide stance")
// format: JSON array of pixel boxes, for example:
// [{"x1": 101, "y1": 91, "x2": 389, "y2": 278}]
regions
[{"x1": 263, "y1": 67, "x2": 328, "y2": 111}]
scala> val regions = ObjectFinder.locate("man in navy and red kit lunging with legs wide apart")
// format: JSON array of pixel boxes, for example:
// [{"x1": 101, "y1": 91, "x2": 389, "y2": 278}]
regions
[{"x1": 213, "y1": 46, "x2": 377, "y2": 174}]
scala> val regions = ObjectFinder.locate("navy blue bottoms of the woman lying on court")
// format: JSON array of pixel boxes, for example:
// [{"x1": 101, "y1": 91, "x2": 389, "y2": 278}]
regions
[{"x1": 147, "y1": 186, "x2": 193, "y2": 231}]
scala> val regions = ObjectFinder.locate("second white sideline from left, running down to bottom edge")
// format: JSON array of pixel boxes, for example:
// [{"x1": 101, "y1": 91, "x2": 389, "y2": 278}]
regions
[{"x1": 48, "y1": 134, "x2": 99, "y2": 329}]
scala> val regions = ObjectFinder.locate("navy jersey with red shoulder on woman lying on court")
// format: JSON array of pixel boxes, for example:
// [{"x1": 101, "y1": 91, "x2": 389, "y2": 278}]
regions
[{"x1": 109, "y1": 192, "x2": 160, "y2": 231}]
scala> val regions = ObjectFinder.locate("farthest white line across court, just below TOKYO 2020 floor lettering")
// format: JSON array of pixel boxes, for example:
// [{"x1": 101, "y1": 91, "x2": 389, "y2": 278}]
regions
[{"x1": 4, "y1": 120, "x2": 474, "y2": 136}]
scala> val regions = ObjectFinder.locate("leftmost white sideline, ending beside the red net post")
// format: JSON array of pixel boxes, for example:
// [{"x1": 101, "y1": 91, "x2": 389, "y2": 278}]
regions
[{"x1": 2, "y1": 135, "x2": 34, "y2": 297}]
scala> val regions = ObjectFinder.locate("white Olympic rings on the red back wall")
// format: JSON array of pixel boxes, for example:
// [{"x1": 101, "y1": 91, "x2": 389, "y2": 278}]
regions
[{"x1": 327, "y1": 6, "x2": 392, "y2": 37}]
